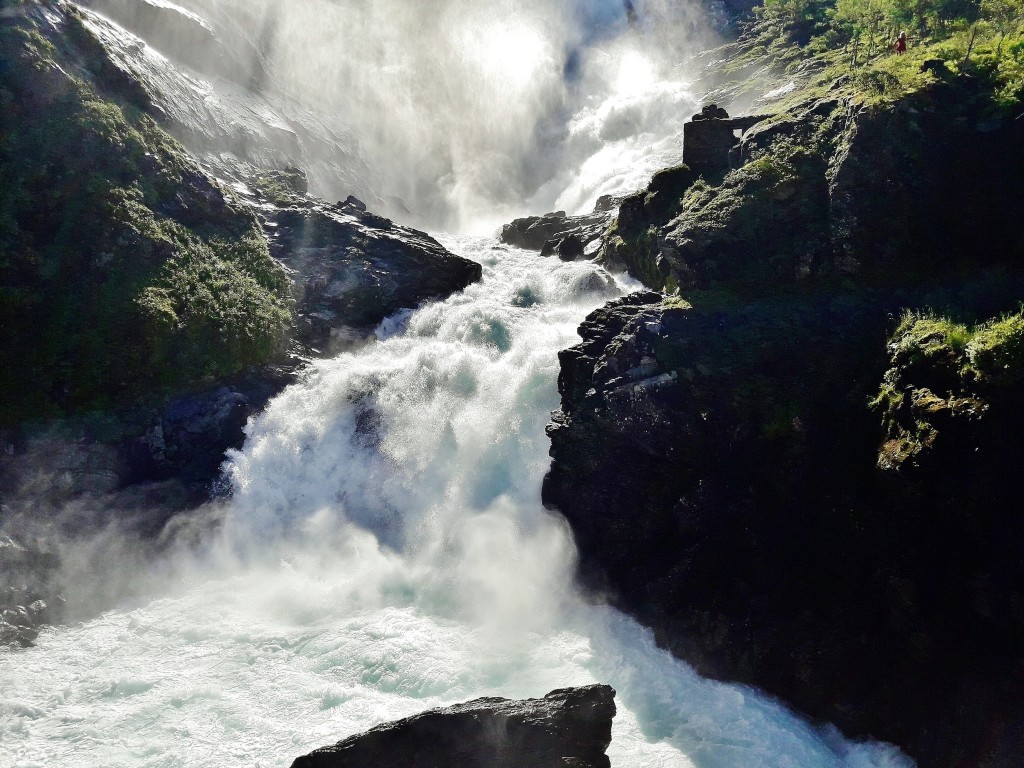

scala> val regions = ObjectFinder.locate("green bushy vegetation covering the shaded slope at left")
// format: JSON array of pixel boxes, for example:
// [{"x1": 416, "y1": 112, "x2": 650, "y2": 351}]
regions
[{"x1": 0, "y1": 9, "x2": 290, "y2": 424}]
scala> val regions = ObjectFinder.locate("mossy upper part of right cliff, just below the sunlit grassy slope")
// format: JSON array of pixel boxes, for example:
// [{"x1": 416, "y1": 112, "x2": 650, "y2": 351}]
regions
[{"x1": 601, "y1": 79, "x2": 1024, "y2": 296}]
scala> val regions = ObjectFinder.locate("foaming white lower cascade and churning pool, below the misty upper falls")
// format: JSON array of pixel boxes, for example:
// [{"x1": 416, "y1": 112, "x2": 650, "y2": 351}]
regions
[{"x1": 0, "y1": 237, "x2": 910, "y2": 768}]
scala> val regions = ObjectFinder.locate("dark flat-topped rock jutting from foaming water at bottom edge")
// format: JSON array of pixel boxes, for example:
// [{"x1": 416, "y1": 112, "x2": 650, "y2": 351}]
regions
[{"x1": 292, "y1": 685, "x2": 615, "y2": 768}]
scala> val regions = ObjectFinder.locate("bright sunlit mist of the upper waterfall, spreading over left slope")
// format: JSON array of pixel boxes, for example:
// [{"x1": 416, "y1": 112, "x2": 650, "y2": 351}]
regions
[{"x1": 88, "y1": 0, "x2": 714, "y2": 233}]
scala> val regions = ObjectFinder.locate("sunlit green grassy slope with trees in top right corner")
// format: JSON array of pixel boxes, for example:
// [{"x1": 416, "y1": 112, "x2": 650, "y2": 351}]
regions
[{"x1": 718, "y1": 0, "x2": 1024, "y2": 117}]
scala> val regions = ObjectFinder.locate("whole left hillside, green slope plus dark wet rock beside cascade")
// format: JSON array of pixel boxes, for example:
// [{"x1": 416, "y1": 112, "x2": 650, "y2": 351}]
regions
[{"x1": 0, "y1": 0, "x2": 481, "y2": 642}]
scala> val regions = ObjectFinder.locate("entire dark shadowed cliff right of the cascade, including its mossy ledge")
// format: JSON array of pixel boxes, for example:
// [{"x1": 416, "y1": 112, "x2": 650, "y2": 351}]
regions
[{"x1": 544, "y1": 70, "x2": 1024, "y2": 768}]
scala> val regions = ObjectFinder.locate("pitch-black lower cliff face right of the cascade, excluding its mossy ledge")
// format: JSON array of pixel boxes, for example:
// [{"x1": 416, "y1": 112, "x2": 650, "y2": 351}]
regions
[{"x1": 543, "y1": 286, "x2": 1024, "y2": 767}]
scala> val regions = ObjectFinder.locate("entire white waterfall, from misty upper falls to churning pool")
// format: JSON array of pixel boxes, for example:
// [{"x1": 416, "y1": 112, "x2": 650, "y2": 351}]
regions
[{"x1": 0, "y1": 0, "x2": 909, "y2": 768}]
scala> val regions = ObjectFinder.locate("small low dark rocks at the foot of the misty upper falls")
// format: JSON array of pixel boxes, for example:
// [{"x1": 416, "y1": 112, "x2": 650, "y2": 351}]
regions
[{"x1": 501, "y1": 202, "x2": 616, "y2": 261}]
